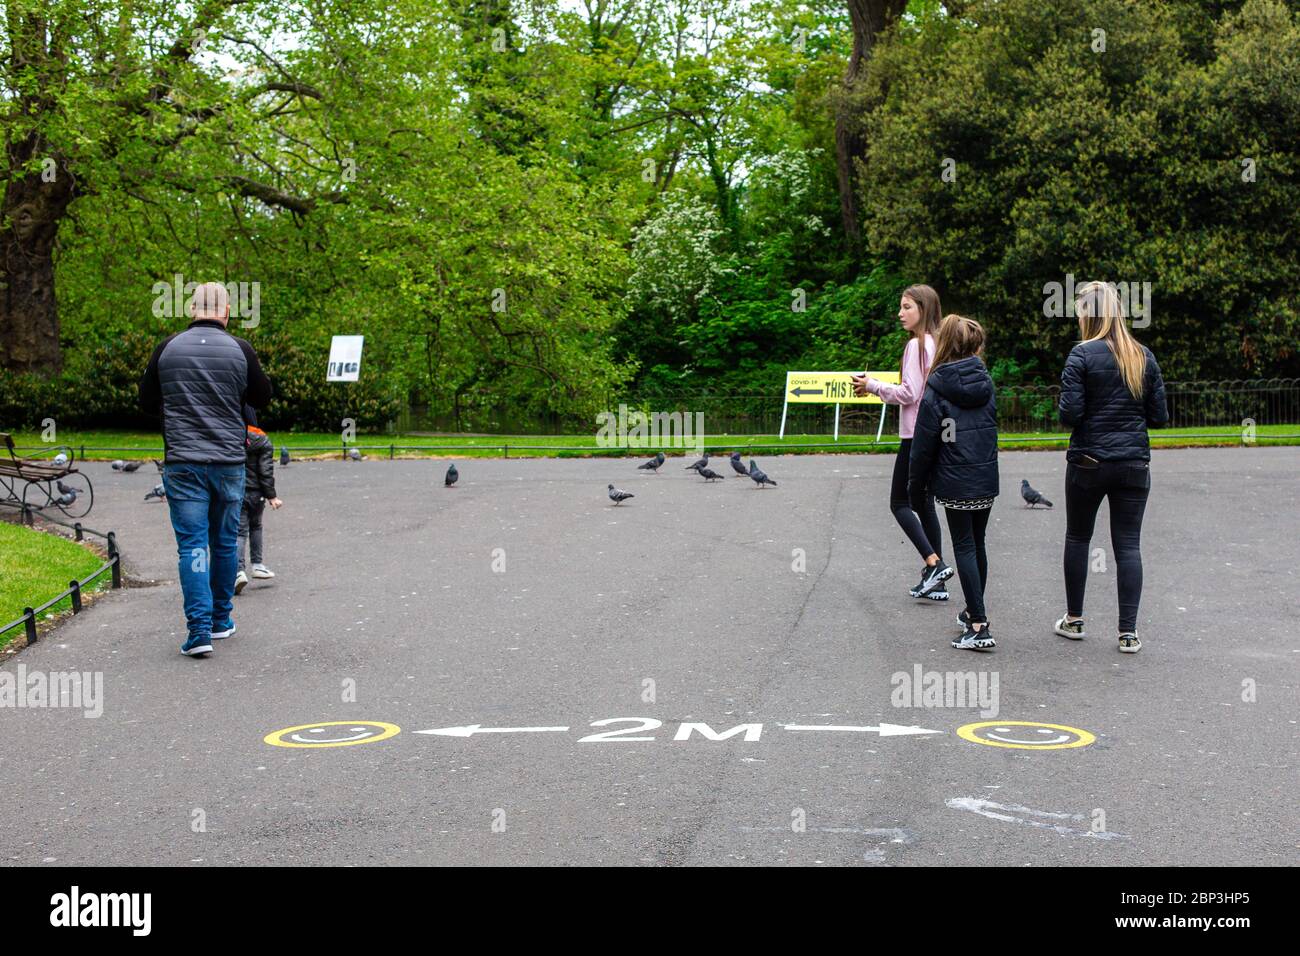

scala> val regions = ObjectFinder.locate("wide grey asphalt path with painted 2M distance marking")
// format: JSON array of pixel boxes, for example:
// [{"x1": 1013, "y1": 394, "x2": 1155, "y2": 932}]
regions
[{"x1": 0, "y1": 449, "x2": 1300, "y2": 866}]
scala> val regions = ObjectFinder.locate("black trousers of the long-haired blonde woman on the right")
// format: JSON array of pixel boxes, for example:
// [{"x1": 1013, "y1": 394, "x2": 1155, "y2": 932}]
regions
[{"x1": 1065, "y1": 460, "x2": 1151, "y2": 633}]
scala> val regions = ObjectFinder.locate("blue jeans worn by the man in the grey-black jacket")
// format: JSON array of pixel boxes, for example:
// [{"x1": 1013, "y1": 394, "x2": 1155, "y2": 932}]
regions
[{"x1": 163, "y1": 463, "x2": 244, "y2": 646}]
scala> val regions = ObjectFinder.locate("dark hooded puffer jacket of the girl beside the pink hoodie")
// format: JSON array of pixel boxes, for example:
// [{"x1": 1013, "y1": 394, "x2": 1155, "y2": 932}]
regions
[{"x1": 909, "y1": 355, "x2": 998, "y2": 501}]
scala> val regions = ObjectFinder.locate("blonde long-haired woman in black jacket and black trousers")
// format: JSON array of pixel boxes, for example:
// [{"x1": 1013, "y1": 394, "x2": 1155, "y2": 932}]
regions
[{"x1": 1054, "y1": 282, "x2": 1169, "y2": 654}]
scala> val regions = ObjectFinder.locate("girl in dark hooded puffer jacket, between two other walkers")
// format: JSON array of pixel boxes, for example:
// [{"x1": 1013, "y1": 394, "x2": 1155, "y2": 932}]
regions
[{"x1": 909, "y1": 315, "x2": 997, "y2": 650}]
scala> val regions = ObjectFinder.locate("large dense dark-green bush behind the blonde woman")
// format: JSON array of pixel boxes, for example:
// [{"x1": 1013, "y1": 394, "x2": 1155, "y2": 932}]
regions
[{"x1": 861, "y1": 0, "x2": 1300, "y2": 378}]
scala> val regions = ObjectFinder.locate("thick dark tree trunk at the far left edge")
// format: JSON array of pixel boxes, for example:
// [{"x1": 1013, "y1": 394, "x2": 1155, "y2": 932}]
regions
[{"x1": 0, "y1": 134, "x2": 74, "y2": 372}]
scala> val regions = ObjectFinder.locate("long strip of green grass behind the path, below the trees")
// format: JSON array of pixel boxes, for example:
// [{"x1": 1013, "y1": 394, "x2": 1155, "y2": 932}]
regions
[{"x1": 5, "y1": 424, "x2": 1300, "y2": 460}]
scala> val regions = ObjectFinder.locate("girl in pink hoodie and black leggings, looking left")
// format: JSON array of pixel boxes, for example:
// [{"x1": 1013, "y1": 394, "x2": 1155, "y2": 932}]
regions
[{"x1": 853, "y1": 285, "x2": 953, "y2": 601}]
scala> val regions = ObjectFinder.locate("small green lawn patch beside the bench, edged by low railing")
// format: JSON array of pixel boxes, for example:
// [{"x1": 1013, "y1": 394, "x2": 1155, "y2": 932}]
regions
[{"x1": 0, "y1": 520, "x2": 112, "y2": 648}]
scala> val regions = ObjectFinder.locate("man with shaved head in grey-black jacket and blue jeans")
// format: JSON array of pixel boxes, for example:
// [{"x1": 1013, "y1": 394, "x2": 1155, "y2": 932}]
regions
[{"x1": 140, "y1": 282, "x2": 270, "y2": 657}]
